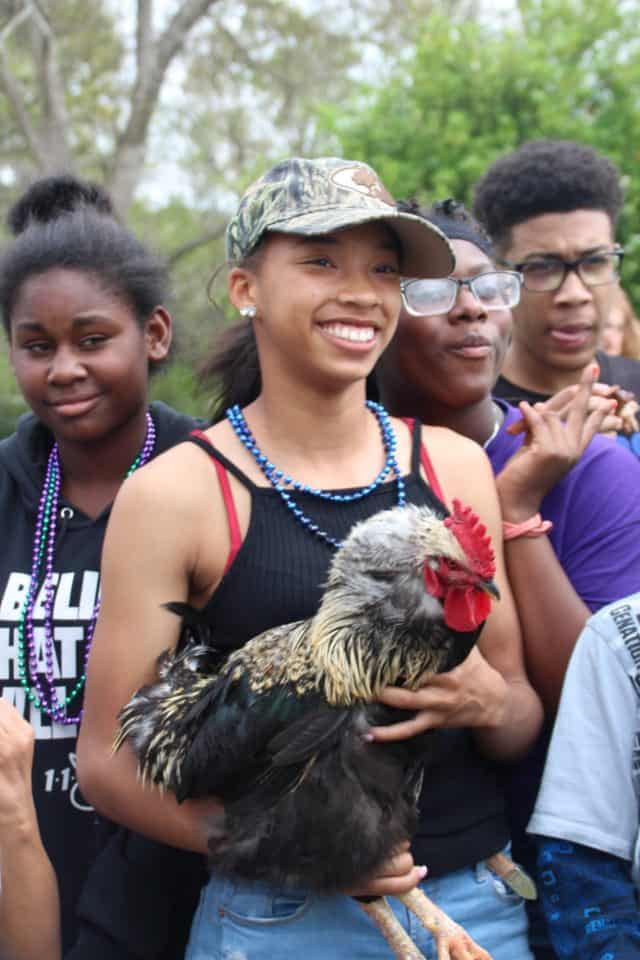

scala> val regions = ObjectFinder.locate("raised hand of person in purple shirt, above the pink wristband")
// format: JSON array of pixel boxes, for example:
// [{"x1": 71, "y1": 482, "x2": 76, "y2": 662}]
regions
[{"x1": 496, "y1": 365, "x2": 616, "y2": 523}]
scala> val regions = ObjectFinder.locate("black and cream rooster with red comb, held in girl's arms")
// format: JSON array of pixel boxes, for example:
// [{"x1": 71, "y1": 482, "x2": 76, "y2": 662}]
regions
[{"x1": 115, "y1": 501, "x2": 498, "y2": 960}]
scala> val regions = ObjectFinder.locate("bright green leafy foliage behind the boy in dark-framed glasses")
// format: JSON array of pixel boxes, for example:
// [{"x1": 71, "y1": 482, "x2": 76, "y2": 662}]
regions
[{"x1": 324, "y1": 0, "x2": 640, "y2": 304}]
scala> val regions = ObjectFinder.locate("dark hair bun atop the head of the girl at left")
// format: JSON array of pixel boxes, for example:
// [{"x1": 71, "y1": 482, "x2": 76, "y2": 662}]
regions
[{"x1": 7, "y1": 174, "x2": 114, "y2": 236}]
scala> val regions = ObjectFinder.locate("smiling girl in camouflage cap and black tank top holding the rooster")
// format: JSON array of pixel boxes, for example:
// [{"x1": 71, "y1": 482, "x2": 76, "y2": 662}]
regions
[{"x1": 79, "y1": 158, "x2": 541, "y2": 960}]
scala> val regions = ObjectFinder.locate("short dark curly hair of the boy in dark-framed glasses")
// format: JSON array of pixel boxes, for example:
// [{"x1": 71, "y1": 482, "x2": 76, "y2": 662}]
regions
[{"x1": 473, "y1": 140, "x2": 623, "y2": 249}]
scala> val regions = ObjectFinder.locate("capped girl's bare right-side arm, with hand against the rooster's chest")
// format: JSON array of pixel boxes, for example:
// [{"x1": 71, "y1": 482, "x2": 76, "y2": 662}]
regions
[{"x1": 373, "y1": 427, "x2": 542, "y2": 760}]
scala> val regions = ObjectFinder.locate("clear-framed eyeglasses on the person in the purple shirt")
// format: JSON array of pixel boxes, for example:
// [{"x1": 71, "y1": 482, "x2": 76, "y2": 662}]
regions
[{"x1": 400, "y1": 270, "x2": 522, "y2": 317}]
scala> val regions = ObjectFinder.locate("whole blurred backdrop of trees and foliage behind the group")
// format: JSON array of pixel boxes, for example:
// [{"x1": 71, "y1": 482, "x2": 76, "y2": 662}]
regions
[{"x1": 0, "y1": 0, "x2": 640, "y2": 438}]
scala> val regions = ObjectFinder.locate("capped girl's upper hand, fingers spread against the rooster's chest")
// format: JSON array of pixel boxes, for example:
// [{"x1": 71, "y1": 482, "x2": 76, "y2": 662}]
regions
[{"x1": 369, "y1": 647, "x2": 509, "y2": 742}]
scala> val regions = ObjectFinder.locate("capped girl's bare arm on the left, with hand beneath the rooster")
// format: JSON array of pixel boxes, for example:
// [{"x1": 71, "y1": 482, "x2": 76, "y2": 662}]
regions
[{"x1": 78, "y1": 438, "x2": 426, "y2": 896}]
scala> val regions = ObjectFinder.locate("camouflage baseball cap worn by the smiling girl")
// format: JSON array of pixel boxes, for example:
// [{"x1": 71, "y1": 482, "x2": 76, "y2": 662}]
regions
[{"x1": 226, "y1": 157, "x2": 455, "y2": 277}]
